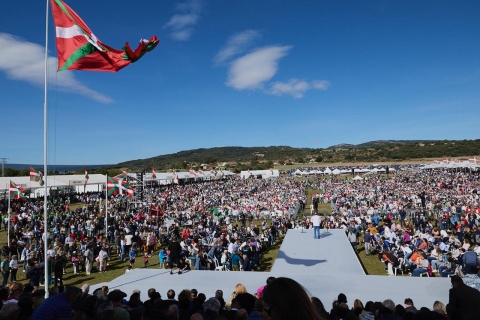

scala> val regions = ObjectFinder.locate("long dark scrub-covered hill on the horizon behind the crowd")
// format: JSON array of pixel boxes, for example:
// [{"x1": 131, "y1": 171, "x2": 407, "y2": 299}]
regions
[{"x1": 115, "y1": 139, "x2": 480, "y2": 171}]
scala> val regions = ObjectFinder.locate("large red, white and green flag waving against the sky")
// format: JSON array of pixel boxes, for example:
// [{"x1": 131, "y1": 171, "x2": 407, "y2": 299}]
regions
[{"x1": 50, "y1": 0, "x2": 159, "y2": 72}]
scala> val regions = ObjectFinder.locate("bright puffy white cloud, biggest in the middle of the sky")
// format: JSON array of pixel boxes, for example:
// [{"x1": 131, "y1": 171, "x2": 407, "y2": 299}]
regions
[{"x1": 227, "y1": 46, "x2": 291, "y2": 90}]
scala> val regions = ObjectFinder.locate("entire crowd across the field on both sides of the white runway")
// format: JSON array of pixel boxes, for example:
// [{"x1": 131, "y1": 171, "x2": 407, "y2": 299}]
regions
[{"x1": 0, "y1": 169, "x2": 480, "y2": 319}]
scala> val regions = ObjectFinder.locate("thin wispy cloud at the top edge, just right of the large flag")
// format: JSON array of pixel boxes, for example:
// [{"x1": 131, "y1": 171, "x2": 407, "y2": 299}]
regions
[{"x1": 165, "y1": 0, "x2": 202, "y2": 41}]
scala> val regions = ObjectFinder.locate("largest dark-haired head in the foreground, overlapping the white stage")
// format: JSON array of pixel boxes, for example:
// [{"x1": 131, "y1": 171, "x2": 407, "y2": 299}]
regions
[{"x1": 263, "y1": 277, "x2": 324, "y2": 320}]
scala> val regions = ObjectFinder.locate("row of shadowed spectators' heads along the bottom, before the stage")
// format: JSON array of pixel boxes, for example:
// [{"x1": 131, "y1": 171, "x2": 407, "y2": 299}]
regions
[{"x1": 0, "y1": 276, "x2": 480, "y2": 320}]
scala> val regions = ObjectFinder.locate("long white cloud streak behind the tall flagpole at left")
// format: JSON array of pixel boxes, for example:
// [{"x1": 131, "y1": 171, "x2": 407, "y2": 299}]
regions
[{"x1": 0, "y1": 33, "x2": 113, "y2": 103}]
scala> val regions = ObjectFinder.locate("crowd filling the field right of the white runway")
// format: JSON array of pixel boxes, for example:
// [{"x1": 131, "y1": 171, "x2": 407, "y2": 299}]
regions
[{"x1": 308, "y1": 169, "x2": 480, "y2": 277}]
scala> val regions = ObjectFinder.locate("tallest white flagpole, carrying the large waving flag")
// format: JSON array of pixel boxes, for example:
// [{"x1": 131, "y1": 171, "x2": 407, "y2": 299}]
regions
[{"x1": 43, "y1": 0, "x2": 50, "y2": 299}]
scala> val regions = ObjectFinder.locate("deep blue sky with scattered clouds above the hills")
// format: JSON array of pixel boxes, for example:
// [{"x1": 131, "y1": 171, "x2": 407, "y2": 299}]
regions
[{"x1": 0, "y1": 0, "x2": 480, "y2": 165}]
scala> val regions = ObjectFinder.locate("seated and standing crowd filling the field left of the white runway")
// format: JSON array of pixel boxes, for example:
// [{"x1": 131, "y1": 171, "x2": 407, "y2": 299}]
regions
[{"x1": 0, "y1": 178, "x2": 306, "y2": 288}]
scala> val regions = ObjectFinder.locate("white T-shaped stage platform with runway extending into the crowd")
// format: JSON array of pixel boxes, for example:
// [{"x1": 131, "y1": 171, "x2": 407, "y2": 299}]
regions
[{"x1": 91, "y1": 229, "x2": 451, "y2": 310}]
